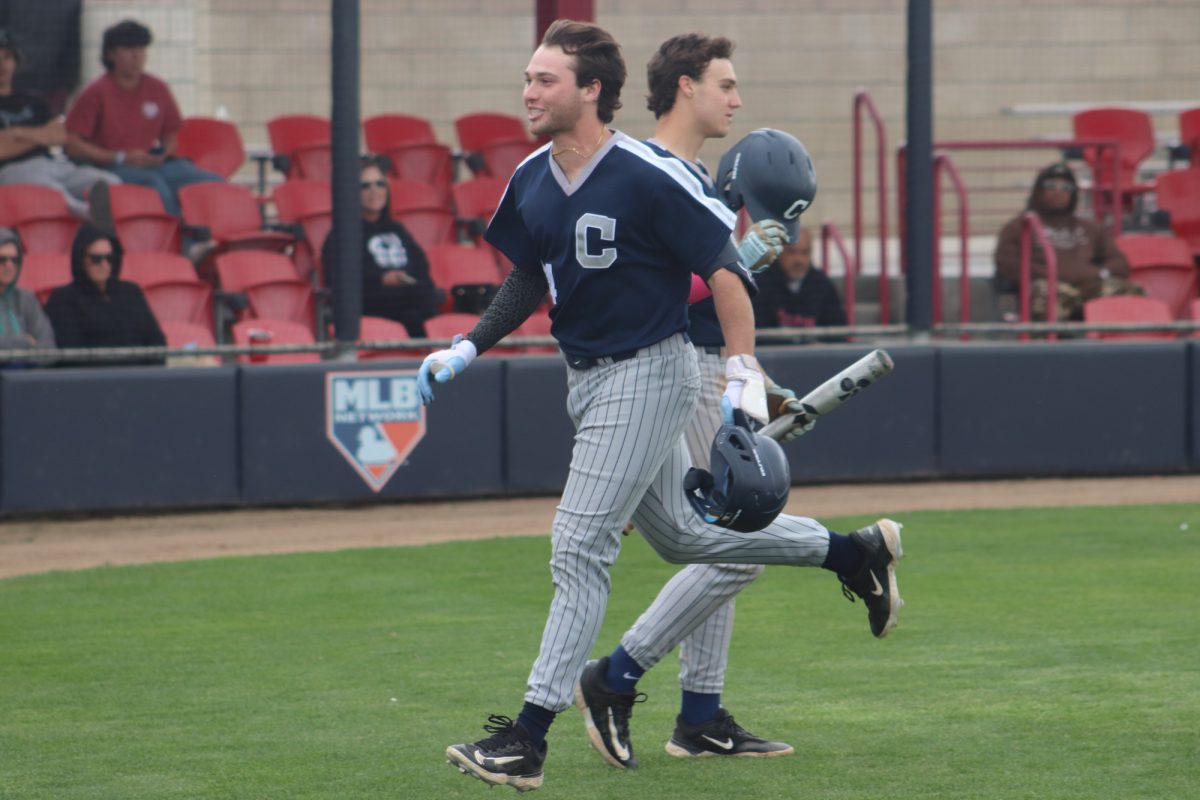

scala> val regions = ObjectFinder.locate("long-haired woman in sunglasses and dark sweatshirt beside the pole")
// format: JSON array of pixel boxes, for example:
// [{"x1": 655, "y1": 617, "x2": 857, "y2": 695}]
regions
[{"x1": 320, "y1": 157, "x2": 445, "y2": 338}]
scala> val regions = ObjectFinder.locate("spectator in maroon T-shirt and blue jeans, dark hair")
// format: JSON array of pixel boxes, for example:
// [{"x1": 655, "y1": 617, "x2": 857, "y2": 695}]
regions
[{"x1": 66, "y1": 19, "x2": 223, "y2": 216}]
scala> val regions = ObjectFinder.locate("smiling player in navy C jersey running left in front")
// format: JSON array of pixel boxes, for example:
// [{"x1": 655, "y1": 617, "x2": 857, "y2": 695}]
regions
[{"x1": 427, "y1": 20, "x2": 901, "y2": 792}]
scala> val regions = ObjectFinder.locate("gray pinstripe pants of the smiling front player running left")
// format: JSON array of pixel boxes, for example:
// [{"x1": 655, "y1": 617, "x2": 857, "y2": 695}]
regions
[{"x1": 524, "y1": 335, "x2": 829, "y2": 711}]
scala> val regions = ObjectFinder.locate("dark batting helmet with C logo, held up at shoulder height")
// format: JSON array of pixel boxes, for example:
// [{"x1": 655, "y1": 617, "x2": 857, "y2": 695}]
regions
[{"x1": 716, "y1": 128, "x2": 817, "y2": 241}]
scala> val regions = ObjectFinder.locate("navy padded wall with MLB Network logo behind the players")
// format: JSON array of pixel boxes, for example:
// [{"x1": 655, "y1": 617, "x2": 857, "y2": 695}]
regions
[{"x1": 0, "y1": 342, "x2": 1200, "y2": 516}]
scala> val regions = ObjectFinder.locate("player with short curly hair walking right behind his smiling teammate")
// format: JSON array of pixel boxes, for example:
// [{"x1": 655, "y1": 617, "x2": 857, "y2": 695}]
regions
[{"x1": 575, "y1": 34, "x2": 815, "y2": 768}]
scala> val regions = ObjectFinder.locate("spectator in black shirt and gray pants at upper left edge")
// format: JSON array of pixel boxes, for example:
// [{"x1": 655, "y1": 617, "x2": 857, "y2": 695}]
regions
[{"x1": 0, "y1": 29, "x2": 120, "y2": 218}]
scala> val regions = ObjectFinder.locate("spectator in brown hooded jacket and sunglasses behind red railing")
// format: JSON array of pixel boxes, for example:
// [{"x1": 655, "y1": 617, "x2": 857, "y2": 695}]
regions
[{"x1": 996, "y1": 163, "x2": 1142, "y2": 320}]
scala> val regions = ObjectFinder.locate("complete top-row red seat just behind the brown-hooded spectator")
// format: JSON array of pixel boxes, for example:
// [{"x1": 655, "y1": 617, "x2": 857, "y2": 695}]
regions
[{"x1": 1072, "y1": 107, "x2": 1157, "y2": 214}]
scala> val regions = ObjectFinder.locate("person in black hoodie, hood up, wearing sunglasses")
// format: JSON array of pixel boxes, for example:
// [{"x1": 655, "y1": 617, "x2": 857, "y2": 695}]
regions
[{"x1": 46, "y1": 223, "x2": 167, "y2": 366}]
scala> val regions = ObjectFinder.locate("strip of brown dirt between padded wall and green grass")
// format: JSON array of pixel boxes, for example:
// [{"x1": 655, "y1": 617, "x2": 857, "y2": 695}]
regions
[{"x1": 0, "y1": 475, "x2": 1200, "y2": 578}]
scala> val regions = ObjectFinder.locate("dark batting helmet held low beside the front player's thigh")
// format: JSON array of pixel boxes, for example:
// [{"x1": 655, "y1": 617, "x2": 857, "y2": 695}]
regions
[{"x1": 683, "y1": 425, "x2": 792, "y2": 533}]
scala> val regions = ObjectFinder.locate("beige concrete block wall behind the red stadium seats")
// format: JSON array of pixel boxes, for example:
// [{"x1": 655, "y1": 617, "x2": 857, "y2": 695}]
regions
[{"x1": 72, "y1": 0, "x2": 1200, "y2": 233}]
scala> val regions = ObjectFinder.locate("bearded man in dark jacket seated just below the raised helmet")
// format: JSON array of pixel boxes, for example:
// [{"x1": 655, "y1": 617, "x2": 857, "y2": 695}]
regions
[{"x1": 754, "y1": 228, "x2": 846, "y2": 341}]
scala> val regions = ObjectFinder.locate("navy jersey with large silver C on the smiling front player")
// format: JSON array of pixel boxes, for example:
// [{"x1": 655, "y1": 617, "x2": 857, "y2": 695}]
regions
[{"x1": 485, "y1": 131, "x2": 744, "y2": 357}]
